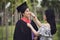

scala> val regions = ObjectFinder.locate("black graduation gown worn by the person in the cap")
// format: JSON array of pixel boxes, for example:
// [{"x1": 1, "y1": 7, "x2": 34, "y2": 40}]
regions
[{"x1": 13, "y1": 20, "x2": 38, "y2": 40}]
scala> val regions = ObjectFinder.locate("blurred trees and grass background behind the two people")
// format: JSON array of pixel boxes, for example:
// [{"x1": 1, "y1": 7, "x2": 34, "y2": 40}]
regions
[{"x1": 0, "y1": 0, "x2": 60, "y2": 40}]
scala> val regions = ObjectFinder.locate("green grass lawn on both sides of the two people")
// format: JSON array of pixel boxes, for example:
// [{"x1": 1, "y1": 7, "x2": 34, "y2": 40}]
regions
[{"x1": 0, "y1": 24, "x2": 60, "y2": 40}]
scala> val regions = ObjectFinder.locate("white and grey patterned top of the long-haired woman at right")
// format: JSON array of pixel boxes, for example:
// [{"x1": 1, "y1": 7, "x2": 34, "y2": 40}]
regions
[{"x1": 38, "y1": 25, "x2": 52, "y2": 40}]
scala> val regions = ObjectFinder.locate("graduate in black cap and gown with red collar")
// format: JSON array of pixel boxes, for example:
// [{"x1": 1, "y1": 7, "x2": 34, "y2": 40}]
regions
[{"x1": 13, "y1": 2, "x2": 38, "y2": 40}]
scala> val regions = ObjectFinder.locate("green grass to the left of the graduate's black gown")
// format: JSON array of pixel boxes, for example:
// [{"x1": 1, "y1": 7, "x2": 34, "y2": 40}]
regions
[{"x1": 0, "y1": 26, "x2": 15, "y2": 40}]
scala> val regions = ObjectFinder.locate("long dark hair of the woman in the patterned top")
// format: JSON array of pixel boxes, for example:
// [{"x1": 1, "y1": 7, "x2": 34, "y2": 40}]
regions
[{"x1": 45, "y1": 8, "x2": 56, "y2": 35}]
